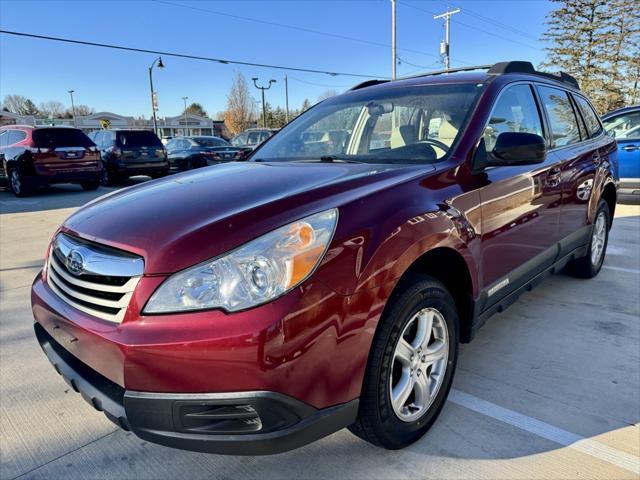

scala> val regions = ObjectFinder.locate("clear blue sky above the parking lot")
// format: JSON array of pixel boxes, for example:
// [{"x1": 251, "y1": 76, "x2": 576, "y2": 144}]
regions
[{"x1": 0, "y1": 0, "x2": 553, "y2": 117}]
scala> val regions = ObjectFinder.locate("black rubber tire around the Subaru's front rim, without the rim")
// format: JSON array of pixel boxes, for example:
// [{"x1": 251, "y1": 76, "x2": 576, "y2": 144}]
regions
[{"x1": 374, "y1": 279, "x2": 459, "y2": 448}]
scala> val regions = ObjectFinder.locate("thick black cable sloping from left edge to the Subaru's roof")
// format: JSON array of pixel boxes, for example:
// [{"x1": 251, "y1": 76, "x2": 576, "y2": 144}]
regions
[{"x1": 0, "y1": 30, "x2": 385, "y2": 78}]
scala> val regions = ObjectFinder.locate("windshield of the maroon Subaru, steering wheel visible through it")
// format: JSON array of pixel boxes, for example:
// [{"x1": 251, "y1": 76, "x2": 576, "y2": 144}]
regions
[{"x1": 253, "y1": 84, "x2": 481, "y2": 163}]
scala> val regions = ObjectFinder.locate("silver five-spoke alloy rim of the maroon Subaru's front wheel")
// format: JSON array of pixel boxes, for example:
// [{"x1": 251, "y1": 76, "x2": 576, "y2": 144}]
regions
[{"x1": 389, "y1": 308, "x2": 449, "y2": 422}]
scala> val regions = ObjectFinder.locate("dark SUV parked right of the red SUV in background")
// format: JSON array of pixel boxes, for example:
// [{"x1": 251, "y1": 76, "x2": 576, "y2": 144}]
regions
[{"x1": 89, "y1": 130, "x2": 169, "y2": 185}]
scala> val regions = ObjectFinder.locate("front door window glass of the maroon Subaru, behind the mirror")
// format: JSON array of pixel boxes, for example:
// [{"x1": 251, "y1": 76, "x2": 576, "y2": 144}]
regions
[{"x1": 483, "y1": 85, "x2": 542, "y2": 152}]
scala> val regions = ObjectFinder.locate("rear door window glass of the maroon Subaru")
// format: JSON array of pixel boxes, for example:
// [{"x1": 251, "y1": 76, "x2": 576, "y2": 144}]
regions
[{"x1": 538, "y1": 86, "x2": 580, "y2": 147}]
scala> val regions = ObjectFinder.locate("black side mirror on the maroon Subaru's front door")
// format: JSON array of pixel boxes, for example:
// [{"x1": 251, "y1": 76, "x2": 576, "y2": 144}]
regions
[{"x1": 487, "y1": 132, "x2": 547, "y2": 165}]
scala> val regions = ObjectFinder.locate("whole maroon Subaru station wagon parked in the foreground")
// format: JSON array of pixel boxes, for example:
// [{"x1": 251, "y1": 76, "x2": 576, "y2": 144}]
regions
[{"x1": 32, "y1": 62, "x2": 617, "y2": 455}]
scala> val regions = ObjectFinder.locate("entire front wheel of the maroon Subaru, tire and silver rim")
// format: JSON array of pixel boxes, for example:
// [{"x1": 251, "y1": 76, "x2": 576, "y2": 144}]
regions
[{"x1": 349, "y1": 275, "x2": 459, "y2": 450}]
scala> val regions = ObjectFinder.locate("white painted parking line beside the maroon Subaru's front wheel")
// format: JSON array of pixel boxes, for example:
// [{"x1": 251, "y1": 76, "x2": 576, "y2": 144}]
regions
[{"x1": 449, "y1": 389, "x2": 640, "y2": 475}]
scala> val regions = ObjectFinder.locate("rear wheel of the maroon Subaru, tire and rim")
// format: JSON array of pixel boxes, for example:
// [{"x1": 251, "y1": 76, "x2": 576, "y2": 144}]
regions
[{"x1": 567, "y1": 200, "x2": 611, "y2": 278}]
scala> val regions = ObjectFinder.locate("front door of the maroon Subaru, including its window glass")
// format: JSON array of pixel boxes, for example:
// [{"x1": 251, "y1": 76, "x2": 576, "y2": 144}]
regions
[{"x1": 480, "y1": 83, "x2": 561, "y2": 300}]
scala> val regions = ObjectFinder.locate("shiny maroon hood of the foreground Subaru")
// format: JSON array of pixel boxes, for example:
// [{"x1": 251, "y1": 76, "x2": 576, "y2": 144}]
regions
[{"x1": 62, "y1": 162, "x2": 433, "y2": 275}]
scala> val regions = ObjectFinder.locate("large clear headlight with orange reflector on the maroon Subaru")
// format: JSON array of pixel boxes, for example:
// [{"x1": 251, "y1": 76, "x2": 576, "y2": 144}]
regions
[{"x1": 144, "y1": 209, "x2": 338, "y2": 314}]
